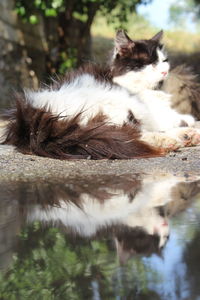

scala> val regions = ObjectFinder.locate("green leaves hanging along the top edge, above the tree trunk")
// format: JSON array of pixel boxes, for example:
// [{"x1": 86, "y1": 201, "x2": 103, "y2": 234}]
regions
[{"x1": 15, "y1": 0, "x2": 151, "y2": 22}]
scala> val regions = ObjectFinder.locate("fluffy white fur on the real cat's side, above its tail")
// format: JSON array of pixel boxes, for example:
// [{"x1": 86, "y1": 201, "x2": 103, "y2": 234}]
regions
[{"x1": 26, "y1": 74, "x2": 146, "y2": 125}]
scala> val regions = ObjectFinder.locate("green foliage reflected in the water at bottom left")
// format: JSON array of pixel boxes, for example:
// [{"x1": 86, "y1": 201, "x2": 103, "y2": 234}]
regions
[{"x1": 0, "y1": 224, "x2": 114, "y2": 299}]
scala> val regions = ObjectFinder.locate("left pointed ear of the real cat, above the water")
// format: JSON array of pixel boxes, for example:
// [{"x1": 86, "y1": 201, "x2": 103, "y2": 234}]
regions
[{"x1": 115, "y1": 30, "x2": 135, "y2": 56}]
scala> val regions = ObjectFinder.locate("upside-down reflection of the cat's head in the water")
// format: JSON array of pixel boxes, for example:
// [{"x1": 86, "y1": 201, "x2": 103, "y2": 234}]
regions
[{"x1": 115, "y1": 206, "x2": 170, "y2": 263}]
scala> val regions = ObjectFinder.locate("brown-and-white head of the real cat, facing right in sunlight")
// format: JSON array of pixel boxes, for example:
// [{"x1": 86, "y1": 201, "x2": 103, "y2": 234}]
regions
[{"x1": 111, "y1": 30, "x2": 169, "y2": 92}]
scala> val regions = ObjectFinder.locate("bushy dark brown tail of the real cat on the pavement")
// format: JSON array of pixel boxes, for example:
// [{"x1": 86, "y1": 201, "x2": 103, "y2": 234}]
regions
[{"x1": 3, "y1": 100, "x2": 164, "y2": 159}]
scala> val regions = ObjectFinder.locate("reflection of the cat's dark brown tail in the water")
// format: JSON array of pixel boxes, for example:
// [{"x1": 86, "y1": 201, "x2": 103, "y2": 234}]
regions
[{"x1": 15, "y1": 176, "x2": 141, "y2": 210}]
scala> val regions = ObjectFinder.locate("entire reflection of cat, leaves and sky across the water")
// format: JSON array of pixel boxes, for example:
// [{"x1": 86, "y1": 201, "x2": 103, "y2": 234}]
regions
[{"x1": 0, "y1": 176, "x2": 200, "y2": 300}]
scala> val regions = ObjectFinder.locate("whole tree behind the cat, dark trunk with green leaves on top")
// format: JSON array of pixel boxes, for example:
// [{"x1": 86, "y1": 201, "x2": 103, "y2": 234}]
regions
[{"x1": 15, "y1": 0, "x2": 151, "y2": 74}]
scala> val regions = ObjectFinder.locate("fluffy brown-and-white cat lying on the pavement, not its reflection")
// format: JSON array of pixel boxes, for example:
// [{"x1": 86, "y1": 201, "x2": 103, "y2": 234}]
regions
[{"x1": 3, "y1": 30, "x2": 200, "y2": 159}]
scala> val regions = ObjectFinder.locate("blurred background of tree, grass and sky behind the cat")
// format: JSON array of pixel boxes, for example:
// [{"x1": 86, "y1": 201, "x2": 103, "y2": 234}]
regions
[{"x1": 0, "y1": 0, "x2": 200, "y2": 107}]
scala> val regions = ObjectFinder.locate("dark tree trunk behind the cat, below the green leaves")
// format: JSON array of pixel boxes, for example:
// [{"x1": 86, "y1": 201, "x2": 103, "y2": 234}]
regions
[{"x1": 44, "y1": 0, "x2": 99, "y2": 74}]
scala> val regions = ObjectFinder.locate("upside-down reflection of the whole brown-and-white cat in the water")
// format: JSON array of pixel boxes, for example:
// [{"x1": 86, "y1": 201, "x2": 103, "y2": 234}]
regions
[{"x1": 1, "y1": 176, "x2": 200, "y2": 263}]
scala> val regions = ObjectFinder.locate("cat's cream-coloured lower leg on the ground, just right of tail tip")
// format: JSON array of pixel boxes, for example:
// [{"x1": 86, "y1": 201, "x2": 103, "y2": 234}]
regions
[{"x1": 141, "y1": 127, "x2": 200, "y2": 151}]
